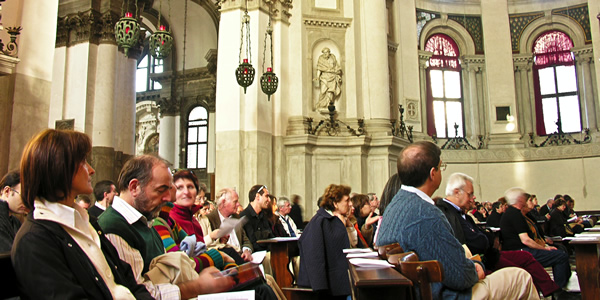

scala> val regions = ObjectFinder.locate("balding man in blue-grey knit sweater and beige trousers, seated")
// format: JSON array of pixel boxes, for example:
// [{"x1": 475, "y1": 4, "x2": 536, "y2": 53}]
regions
[{"x1": 377, "y1": 141, "x2": 539, "y2": 299}]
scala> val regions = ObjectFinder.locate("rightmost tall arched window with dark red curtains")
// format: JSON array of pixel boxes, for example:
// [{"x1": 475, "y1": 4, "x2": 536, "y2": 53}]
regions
[{"x1": 533, "y1": 31, "x2": 581, "y2": 135}]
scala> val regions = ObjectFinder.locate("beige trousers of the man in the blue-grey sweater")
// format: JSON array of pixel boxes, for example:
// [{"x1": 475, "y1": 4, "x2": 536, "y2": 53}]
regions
[{"x1": 471, "y1": 267, "x2": 540, "y2": 300}]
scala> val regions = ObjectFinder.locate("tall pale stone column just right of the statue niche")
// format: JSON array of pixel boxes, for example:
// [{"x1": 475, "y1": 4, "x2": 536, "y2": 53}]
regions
[{"x1": 360, "y1": 0, "x2": 391, "y2": 135}]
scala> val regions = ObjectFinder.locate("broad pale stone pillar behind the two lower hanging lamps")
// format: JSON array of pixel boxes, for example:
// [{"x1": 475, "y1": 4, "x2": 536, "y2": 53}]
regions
[{"x1": 215, "y1": 1, "x2": 289, "y2": 195}]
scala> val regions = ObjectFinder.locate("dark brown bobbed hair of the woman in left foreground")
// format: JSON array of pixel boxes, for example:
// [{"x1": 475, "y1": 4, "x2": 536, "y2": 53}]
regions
[{"x1": 21, "y1": 129, "x2": 92, "y2": 209}]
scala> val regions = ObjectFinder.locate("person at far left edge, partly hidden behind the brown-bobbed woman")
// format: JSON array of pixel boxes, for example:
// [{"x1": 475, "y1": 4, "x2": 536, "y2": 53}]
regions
[{"x1": 0, "y1": 170, "x2": 29, "y2": 252}]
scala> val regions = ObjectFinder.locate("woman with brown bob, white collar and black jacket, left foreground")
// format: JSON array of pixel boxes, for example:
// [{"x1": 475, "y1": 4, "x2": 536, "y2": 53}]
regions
[{"x1": 11, "y1": 129, "x2": 153, "y2": 299}]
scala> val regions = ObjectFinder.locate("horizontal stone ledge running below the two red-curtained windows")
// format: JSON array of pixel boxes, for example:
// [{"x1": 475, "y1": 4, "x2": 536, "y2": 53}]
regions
[{"x1": 442, "y1": 144, "x2": 600, "y2": 163}]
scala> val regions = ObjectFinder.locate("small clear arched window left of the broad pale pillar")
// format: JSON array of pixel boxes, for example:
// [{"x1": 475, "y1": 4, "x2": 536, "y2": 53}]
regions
[{"x1": 187, "y1": 106, "x2": 208, "y2": 169}]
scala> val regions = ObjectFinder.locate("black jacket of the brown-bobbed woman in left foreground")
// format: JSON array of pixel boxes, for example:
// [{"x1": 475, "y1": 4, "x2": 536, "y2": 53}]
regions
[{"x1": 11, "y1": 211, "x2": 153, "y2": 299}]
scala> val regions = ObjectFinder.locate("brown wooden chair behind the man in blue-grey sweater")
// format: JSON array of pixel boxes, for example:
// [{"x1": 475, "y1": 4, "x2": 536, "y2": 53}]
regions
[{"x1": 388, "y1": 251, "x2": 444, "y2": 299}]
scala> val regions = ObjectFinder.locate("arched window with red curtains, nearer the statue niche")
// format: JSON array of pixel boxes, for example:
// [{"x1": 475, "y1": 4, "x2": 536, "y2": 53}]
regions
[{"x1": 425, "y1": 34, "x2": 464, "y2": 138}]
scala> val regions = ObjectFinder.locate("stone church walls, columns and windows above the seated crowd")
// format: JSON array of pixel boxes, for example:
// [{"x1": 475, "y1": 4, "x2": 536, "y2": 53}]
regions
[{"x1": 0, "y1": 0, "x2": 600, "y2": 216}]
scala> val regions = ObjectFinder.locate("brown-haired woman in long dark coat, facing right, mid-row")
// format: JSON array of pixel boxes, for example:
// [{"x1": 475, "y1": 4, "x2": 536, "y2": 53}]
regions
[{"x1": 298, "y1": 184, "x2": 352, "y2": 299}]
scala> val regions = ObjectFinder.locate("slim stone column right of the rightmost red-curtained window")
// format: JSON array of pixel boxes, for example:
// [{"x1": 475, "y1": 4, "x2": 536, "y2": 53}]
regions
[{"x1": 571, "y1": 47, "x2": 598, "y2": 129}]
